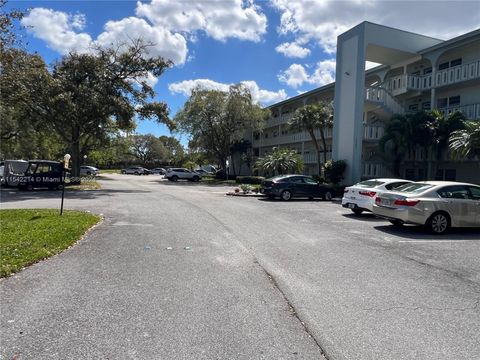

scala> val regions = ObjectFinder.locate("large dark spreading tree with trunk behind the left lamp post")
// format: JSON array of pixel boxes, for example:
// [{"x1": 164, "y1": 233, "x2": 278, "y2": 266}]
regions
[{"x1": 31, "y1": 40, "x2": 174, "y2": 177}]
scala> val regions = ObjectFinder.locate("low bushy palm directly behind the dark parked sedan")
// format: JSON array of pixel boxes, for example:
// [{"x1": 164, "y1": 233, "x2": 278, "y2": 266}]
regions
[{"x1": 255, "y1": 147, "x2": 303, "y2": 175}]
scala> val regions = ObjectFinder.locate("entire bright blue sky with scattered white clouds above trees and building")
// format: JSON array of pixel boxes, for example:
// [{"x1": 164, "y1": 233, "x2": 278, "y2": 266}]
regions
[{"x1": 7, "y1": 0, "x2": 480, "y2": 142}]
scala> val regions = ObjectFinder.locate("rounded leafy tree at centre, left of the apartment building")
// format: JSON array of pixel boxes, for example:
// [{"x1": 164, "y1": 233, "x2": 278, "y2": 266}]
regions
[{"x1": 175, "y1": 85, "x2": 269, "y2": 168}]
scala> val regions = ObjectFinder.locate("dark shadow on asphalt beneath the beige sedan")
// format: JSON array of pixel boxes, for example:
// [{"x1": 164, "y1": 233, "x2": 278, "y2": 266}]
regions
[{"x1": 374, "y1": 225, "x2": 480, "y2": 241}]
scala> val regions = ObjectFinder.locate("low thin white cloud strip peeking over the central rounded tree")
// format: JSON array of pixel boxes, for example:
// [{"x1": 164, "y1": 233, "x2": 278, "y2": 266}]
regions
[{"x1": 168, "y1": 79, "x2": 287, "y2": 104}]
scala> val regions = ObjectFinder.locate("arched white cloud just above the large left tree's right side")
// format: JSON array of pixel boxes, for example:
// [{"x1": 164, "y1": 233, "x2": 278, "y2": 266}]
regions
[{"x1": 96, "y1": 17, "x2": 188, "y2": 65}]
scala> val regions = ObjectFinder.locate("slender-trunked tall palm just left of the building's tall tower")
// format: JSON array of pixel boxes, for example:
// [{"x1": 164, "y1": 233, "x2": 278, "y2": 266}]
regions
[{"x1": 289, "y1": 101, "x2": 333, "y2": 176}]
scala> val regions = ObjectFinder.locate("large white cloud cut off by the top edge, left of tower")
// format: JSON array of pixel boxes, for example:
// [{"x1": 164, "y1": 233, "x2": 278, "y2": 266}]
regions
[{"x1": 136, "y1": 0, "x2": 267, "y2": 41}]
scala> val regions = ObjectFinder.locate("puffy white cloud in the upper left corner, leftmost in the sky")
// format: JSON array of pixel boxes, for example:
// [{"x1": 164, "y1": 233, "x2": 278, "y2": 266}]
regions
[{"x1": 22, "y1": 8, "x2": 92, "y2": 54}]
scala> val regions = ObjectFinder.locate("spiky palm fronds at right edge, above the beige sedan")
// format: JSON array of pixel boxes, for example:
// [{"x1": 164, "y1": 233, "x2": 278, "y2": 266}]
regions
[{"x1": 448, "y1": 120, "x2": 480, "y2": 158}]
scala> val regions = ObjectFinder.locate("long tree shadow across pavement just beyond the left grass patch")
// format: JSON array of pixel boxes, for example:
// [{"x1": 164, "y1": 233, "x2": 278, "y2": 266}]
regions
[{"x1": 0, "y1": 188, "x2": 151, "y2": 203}]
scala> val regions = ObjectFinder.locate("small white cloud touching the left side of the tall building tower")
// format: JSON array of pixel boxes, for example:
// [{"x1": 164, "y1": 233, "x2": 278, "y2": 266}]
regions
[{"x1": 278, "y1": 59, "x2": 336, "y2": 88}]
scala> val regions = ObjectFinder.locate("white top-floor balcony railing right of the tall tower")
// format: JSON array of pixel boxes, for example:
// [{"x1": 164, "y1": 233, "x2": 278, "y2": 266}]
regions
[{"x1": 381, "y1": 61, "x2": 480, "y2": 96}]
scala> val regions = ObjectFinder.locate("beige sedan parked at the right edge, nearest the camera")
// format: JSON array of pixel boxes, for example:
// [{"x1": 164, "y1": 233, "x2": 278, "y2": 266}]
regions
[{"x1": 373, "y1": 181, "x2": 480, "y2": 234}]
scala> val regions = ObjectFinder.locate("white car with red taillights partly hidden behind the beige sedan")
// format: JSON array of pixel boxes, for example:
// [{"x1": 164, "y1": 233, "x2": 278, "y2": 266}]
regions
[{"x1": 342, "y1": 179, "x2": 412, "y2": 215}]
